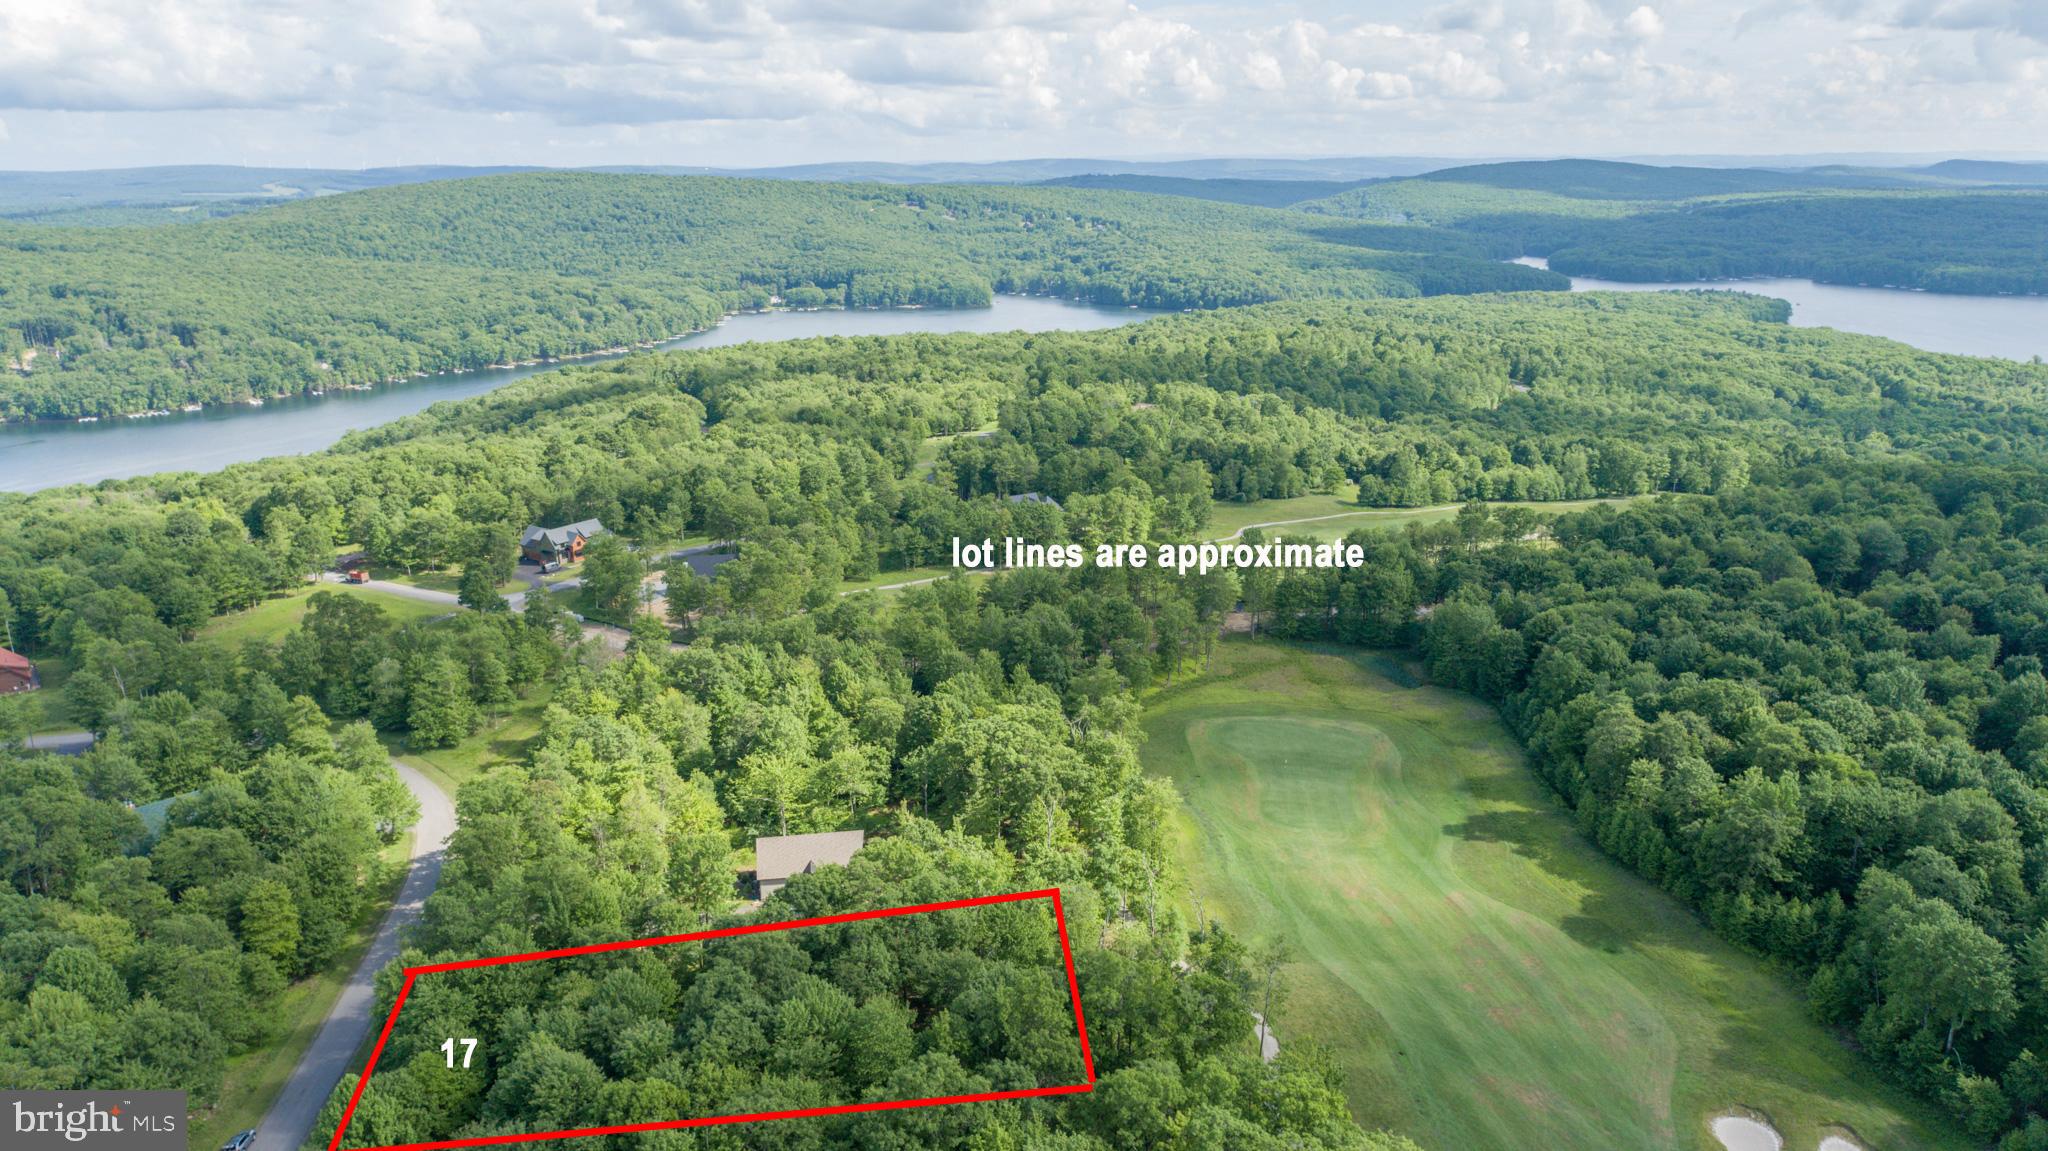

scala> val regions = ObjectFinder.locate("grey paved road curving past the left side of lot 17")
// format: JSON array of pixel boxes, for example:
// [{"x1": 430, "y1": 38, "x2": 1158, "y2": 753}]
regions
[{"x1": 254, "y1": 764, "x2": 455, "y2": 1151}]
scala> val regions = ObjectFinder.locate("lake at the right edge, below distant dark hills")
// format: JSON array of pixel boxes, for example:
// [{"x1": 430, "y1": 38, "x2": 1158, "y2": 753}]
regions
[{"x1": 1516, "y1": 256, "x2": 2048, "y2": 360}]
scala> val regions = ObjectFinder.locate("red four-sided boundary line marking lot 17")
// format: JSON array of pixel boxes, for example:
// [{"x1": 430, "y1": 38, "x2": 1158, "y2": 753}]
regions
[{"x1": 328, "y1": 887, "x2": 1096, "y2": 1151}]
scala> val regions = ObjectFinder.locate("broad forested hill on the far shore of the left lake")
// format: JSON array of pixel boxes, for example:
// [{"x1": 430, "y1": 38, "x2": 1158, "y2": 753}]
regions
[{"x1": 0, "y1": 172, "x2": 1540, "y2": 418}]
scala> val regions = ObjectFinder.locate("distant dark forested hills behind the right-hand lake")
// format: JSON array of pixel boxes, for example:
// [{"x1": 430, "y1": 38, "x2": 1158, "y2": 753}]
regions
[{"x1": 1296, "y1": 160, "x2": 2048, "y2": 295}]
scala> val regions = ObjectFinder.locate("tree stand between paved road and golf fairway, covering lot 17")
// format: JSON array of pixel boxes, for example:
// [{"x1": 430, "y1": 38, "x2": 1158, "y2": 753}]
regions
[{"x1": 319, "y1": 638, "x2": 1411, "y2": 1151}]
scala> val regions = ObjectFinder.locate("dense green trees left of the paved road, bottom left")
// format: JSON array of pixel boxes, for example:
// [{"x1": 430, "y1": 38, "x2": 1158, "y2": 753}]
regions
[{"x1": 0, "y1": 688, "x2": 416, "y2": 1106}]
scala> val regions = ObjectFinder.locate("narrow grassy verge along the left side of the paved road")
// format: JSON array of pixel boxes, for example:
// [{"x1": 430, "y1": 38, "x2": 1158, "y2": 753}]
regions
[{"x1": 186, "y1": 834, "x2": 412, "y2": 1151}]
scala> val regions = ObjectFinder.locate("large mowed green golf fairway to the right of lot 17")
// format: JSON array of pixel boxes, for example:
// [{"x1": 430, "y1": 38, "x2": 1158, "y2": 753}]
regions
[{"x1": 1143, "y1": 641, "x2": 1970, "y2": 1151}]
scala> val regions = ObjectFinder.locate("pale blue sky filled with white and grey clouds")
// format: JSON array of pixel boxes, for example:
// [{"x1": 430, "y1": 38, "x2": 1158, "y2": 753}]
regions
[{"x1": 0, "y1": 0, "x2": 2048, "y2": 168}]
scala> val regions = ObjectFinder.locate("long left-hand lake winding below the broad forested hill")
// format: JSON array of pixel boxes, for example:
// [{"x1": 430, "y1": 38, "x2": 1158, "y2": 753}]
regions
[{"x1": 0, "y1": 295, "x2": 1153, "y2": 492}]
